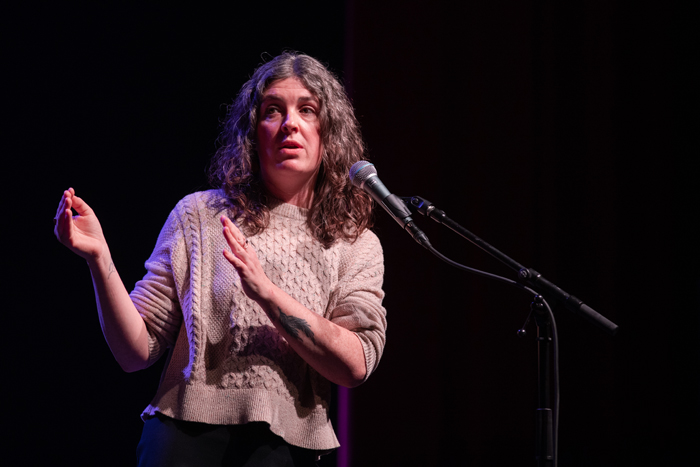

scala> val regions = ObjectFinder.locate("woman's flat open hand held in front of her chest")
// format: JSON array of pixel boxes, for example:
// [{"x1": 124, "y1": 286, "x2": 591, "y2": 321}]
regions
[{"x1": 221, "y1": 216, "x2": 274, "y2": 304}]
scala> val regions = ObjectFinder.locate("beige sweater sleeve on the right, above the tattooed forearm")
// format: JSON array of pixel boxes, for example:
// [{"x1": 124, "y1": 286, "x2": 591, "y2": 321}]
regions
[{"x1": 330, "y1": 231, "x2": 386, "y2": 380}]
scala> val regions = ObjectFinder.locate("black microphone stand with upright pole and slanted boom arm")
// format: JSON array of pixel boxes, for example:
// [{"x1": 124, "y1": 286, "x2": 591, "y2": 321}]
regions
[{"x1": 402, "y1": 196, "x2": 618, "y2": 467}]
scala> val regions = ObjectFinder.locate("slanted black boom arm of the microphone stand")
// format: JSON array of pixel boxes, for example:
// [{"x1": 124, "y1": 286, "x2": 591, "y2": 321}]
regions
[{"x1": 402, "y1": 196, "x2": 618, "y2": 335}]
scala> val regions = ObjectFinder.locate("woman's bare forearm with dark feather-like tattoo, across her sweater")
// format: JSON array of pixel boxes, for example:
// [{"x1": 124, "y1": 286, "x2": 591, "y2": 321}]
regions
[{"x1": 258, "y1": 283, "x2": 367, "y2": 387}]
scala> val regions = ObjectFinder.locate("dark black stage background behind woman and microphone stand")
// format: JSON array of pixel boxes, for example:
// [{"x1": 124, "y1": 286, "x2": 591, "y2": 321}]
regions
[{"x1": 2, "y1": 0, "x2": 700, "y2": 466}]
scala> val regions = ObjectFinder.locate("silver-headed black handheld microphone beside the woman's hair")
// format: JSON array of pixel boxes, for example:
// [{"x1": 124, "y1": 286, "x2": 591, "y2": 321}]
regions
[{"x1": 350, "y1": 161, "x2": 430, "y2": 248}]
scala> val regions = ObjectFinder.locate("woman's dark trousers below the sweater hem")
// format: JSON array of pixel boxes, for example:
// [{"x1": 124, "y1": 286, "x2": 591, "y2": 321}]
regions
[{"x1": 136, "y1": 414, "x2": 319, "y2": 467}]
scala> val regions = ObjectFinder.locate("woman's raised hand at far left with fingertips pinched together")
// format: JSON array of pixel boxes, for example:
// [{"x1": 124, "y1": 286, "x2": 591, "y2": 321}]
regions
[{"x1": 54, "y1": 188, "x2": 108, "y2": 261}]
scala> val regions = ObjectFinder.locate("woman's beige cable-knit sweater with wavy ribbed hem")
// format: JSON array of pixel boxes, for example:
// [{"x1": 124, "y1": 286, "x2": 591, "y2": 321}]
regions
[{"x1": 131, "y1": 190, "x2": 386, "y2": 451}]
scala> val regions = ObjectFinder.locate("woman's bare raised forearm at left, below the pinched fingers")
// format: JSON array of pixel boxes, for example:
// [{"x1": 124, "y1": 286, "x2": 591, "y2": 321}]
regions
[{"x1": 88, "y1": 246, "x2": 148, "y2": 372}]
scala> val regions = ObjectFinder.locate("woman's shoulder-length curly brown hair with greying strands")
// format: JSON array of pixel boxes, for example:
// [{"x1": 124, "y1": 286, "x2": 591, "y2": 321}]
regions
[{"x1": 209, "y1": 52, "x2": 373, "y2": 247}]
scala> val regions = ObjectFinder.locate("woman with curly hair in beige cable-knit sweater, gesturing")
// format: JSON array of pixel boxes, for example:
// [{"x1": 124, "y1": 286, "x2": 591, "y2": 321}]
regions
[{"x1": 55, "y1": 54, "x2": 386, "y2": 466}]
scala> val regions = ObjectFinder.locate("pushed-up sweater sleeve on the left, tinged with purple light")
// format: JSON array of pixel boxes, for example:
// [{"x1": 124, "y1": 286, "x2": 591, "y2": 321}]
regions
[{"x1": 130, "y1": 211, "x2": 185, "y2": 366}]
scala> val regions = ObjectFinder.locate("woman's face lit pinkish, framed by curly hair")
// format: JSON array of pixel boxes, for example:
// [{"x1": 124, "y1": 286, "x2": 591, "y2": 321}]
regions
[{"x1": 256, "y1": 78, "x2": 323, "y2": 201}]
